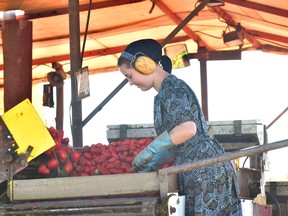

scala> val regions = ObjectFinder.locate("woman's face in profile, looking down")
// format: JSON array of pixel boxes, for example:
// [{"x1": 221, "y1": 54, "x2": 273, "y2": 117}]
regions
[{"x1": 119, "y1": 64, "x2": 153, "y2": 91}]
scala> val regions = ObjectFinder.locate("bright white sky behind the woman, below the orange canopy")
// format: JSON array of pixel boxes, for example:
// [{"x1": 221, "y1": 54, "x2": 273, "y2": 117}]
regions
[{"x1": 32, "y1": 51, "x2": 288, "y2": 181}]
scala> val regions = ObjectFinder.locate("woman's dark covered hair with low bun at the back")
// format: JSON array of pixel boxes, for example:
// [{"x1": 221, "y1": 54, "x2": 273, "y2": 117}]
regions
[{"x1": 117, "y1": 39, "x2": 172, "y2": 73}]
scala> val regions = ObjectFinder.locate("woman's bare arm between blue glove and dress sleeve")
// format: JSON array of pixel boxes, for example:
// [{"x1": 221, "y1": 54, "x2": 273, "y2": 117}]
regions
[{"x1": 169, "y1": 121, "x2": 196, "y2": 145}]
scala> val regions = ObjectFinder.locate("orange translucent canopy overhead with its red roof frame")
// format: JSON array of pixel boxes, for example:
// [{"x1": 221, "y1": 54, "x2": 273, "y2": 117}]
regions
[{"x1": 0, "y1": 0, "x2": 288, "y2": 84}]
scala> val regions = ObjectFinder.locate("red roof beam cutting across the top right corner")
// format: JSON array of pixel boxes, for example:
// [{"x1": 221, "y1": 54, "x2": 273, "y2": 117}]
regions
[{"x1": 224, "y1": 0, "x2": 288, "y2": 17}]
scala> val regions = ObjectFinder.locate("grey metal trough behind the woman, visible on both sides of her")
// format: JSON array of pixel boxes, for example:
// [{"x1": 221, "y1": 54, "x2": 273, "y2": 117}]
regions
[{"x1": 107, "y1": 120, "x2": 264, "y2": 151}]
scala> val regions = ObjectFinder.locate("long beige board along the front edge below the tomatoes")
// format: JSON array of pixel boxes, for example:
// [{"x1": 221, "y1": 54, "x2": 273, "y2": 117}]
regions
[{"x1": 8, "y1": 172, "x2": 178, "y2": 200}]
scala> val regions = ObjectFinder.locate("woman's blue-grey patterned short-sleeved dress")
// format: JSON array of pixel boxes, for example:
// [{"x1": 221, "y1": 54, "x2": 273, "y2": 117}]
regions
[{"x1": 154, "y1": 75, "x2": 242, "y2": 216}]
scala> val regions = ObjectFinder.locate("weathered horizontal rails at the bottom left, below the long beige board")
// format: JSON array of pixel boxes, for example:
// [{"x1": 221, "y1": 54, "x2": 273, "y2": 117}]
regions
[{"x1": 0, "y1": 197, "x2": 160, "y2": 216}]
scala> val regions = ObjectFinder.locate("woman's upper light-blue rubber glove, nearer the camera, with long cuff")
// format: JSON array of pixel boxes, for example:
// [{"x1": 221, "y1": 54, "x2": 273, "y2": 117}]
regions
[{"x1": 132, "y1": 131, "x2": 174, "y2": 170}]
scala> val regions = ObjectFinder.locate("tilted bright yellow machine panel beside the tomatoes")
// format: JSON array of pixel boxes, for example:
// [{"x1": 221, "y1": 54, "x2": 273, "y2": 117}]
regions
[{"x1": 2, "y1": 99, "x2": 55, "y2": 162}]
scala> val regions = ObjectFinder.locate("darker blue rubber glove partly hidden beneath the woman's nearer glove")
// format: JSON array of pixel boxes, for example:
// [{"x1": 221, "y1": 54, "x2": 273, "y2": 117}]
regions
[{"x1": 140, "y1": 150, "x2": 174, "y2": 172}]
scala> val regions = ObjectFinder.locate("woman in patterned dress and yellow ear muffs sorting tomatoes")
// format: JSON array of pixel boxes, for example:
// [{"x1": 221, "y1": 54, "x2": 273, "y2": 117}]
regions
[{"x1": 118, "y1": 39, "x2": 242, "y2": 216}]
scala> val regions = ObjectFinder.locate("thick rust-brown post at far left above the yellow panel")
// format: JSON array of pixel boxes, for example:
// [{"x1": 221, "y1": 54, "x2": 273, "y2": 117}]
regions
[{"x1": 2, "y1": 19, "x2": 32, "y2": 112}]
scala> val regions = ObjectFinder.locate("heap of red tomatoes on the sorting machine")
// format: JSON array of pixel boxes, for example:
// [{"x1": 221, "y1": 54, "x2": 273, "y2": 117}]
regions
[{"x1": 38, "y1": 127, "x2": 173, "y2": 176}]
